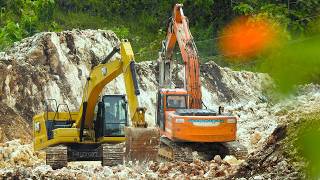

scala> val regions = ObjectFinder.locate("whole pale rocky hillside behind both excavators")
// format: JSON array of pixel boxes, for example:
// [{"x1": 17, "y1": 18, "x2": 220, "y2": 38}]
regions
[{"x1": 0, "y1": 30, "x2": 269, "y2": 147}]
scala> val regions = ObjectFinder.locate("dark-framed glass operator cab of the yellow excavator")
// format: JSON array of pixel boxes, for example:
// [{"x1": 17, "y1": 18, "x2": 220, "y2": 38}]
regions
[{"x1": 95, "y1": 95, "x2": 128, "y2": 138}]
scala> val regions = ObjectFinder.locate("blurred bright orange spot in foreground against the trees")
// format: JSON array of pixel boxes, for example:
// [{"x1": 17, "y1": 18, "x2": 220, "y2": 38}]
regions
[{"x1": 219, "y1": 17, "x2": 275, "y2": 61}]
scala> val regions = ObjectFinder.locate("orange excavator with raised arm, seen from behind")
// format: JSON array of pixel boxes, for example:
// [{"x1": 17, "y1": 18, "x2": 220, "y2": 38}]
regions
[{"x1": 156, "y1": 4, "x2": 247, "y2": 162}]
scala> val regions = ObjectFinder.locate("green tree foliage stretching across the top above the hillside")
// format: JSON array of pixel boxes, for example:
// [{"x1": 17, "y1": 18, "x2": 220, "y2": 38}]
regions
[{"x1": 0, "y1": 0, "x2": 320, "y2": 60}]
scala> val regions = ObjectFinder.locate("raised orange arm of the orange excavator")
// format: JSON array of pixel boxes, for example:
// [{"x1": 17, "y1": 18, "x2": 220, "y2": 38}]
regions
[{"x1": 160, "y1": 4, "x2": 202, "y2": 109}]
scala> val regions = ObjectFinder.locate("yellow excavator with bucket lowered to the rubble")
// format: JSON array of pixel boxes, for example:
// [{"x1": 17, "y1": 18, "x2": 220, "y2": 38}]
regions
[{"x1": 33, "y1": 40, "x2": 159, "y2": 169}]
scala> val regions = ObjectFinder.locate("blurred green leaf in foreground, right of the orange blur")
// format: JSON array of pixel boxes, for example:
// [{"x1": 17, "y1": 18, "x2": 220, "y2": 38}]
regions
[{"x1": 260, "y1": 36, "x2": 320, "y2": 93}]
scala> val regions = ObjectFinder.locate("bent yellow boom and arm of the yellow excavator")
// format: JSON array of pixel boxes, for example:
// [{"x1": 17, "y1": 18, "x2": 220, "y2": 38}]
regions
[{"x1": 75, "y1": 41, "x2": 147, "y2": 140}]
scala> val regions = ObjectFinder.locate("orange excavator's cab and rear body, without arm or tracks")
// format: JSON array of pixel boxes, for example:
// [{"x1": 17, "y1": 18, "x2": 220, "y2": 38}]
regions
[{"x1": 157, "y1": 89, "x2": 237, "y2": 142}]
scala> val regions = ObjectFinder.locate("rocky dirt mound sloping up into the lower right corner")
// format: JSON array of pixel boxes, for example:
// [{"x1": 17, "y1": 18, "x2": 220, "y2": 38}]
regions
[{"x1": 233, "y1": 84, "x2": 320, "y2": 179}]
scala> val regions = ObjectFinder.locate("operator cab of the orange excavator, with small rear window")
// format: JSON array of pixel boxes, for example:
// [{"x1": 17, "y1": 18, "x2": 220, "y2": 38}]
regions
[{"x1": 156, "y1": 89, "x2": 188, "y2": 130}]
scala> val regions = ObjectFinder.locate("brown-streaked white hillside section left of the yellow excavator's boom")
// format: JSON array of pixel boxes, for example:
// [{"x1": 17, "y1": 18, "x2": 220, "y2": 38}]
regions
[{"x1": 0, "y1": 30, "x2": 118, "y2": 141}]
